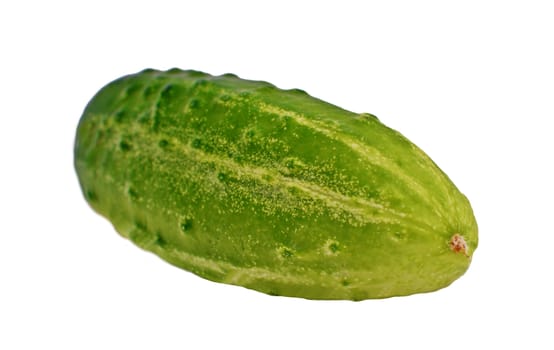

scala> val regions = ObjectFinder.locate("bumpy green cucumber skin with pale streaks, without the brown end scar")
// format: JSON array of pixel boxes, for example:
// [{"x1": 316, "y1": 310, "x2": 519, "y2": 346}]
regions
[{"x1": 75, "y1": 69, "x2": 478, "y2": 300}]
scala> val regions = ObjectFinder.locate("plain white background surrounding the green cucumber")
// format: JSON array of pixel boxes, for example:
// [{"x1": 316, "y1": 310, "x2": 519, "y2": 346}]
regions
[{"x1": 0, "y1": 0, "x2": 554, "y2": 350}]
